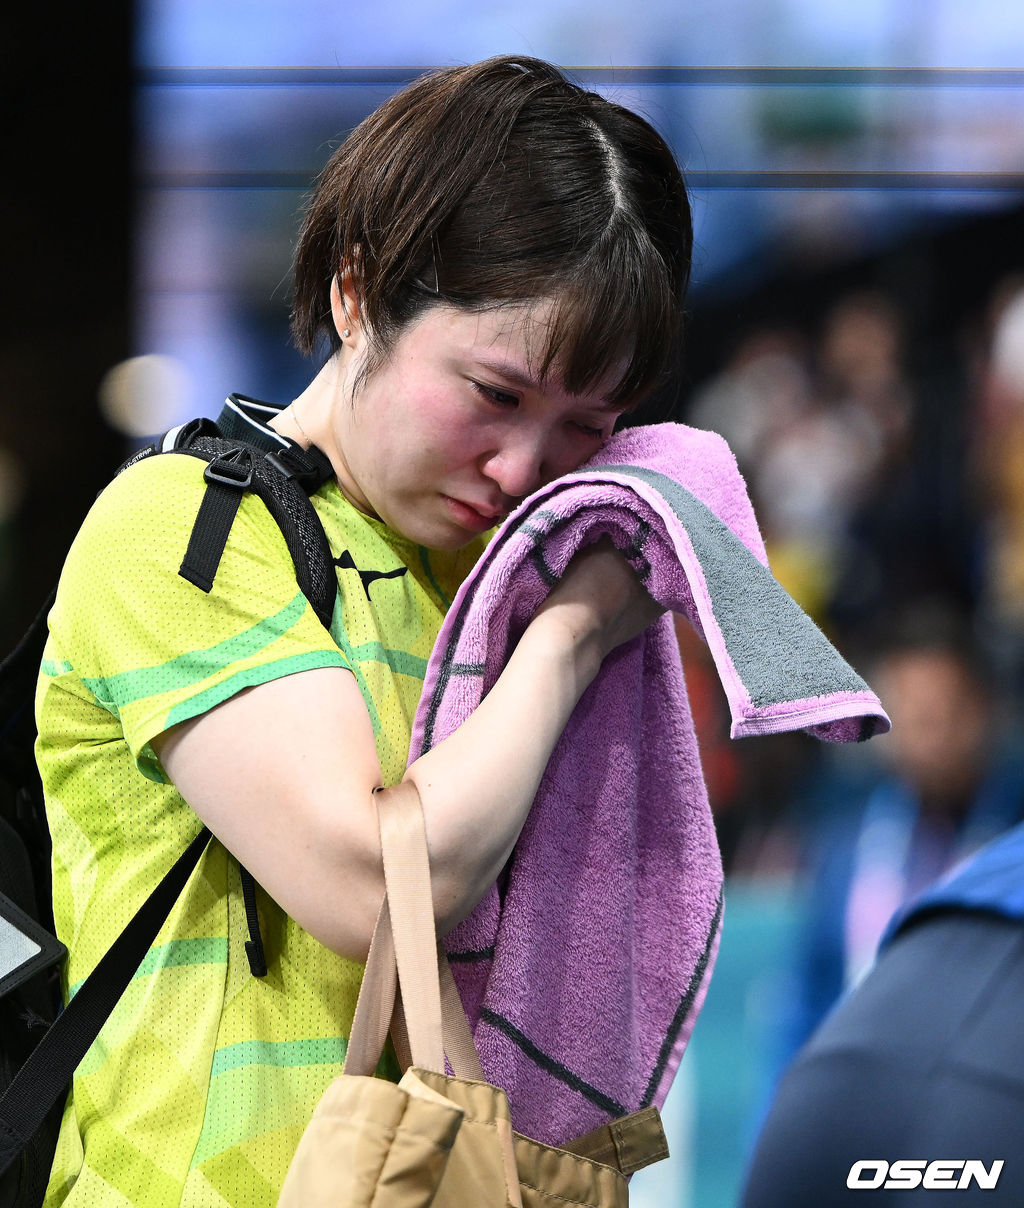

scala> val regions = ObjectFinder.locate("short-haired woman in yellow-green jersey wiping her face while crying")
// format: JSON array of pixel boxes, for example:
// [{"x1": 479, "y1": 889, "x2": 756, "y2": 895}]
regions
[{"x1": 37, "y1": 58, "x2": 691, "y2": 1208}]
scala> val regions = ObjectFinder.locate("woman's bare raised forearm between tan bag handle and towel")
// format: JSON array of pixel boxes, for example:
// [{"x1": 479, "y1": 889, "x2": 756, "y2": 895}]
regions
[{"x1": 406, "y1": 610, "x2": 603, "y2": 931}]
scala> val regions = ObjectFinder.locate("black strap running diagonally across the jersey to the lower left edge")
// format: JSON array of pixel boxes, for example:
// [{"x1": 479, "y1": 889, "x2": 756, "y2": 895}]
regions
[{"x1": 0, "y1": 826, "x2": 211, "y2": 1174}]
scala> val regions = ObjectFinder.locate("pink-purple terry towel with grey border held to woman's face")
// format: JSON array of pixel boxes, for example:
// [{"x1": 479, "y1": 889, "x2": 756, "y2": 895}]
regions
[{"x1": 409, "y1": 424, "x2": 889, "y2": 1144}]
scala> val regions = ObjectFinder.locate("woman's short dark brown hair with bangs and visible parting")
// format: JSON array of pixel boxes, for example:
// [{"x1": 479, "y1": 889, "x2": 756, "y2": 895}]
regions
[{"x1": 292, "y1": 57, "x2": 693, "y2": 405}]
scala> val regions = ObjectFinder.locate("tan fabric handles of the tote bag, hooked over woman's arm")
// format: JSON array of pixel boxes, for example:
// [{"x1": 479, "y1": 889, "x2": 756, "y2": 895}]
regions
[{"x1": 344, "y1": 780, "x2": 483, "y2": 1079}]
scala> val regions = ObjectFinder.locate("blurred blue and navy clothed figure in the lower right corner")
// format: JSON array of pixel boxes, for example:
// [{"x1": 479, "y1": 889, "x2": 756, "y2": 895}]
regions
[{"x1": 743, "y1": 821, "x2": 1024, "y2": 1208}]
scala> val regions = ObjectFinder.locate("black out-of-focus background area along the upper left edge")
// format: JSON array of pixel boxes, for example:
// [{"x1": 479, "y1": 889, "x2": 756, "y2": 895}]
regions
[{"x1": 0, "y1": 0, "x2": 133, "y2": 651}]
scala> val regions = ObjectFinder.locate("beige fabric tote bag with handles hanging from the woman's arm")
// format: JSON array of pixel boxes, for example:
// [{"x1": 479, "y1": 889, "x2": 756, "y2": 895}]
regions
[{"x1": 278, "y1": 782, "x2": 668, "y2": 1208}]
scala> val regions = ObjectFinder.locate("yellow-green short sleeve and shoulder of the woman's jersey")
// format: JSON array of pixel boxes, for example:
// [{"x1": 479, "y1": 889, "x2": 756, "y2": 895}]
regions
[{"x1": 50, "y1": 453, "x2": 347, "y2": 779}]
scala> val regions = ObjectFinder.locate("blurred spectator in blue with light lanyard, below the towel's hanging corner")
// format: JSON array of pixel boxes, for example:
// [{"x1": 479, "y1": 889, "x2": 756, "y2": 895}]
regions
[{"x1": 777, "y1": 604, "x2": 1024, "y2": 1044}]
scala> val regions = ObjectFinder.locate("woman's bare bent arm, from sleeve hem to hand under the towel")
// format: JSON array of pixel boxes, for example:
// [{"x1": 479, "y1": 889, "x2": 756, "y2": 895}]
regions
[{"x1": 156, "y1": 546, "x2": 658, "y2": 959}]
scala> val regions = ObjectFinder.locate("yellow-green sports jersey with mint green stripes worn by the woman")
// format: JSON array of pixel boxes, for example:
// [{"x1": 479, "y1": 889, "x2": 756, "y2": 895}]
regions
[{"x1": 36, "y1": 430, "x2": 483, "y2": 1208}]
